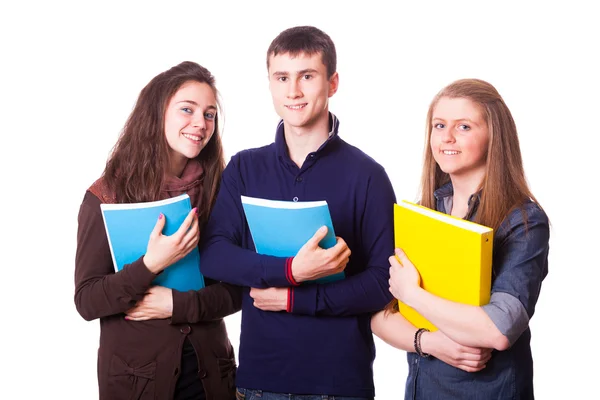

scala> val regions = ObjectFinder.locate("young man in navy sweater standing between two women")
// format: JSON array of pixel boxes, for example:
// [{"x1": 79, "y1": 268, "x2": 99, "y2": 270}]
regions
[{"x1": 202, "y1": 27, "x2": 395, "y2": 400}]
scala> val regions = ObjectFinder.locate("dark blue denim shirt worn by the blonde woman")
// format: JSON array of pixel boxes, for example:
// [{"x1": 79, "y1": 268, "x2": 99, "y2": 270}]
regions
[{"x1": 405, "y1": 183, "x2": 550, "y2": 400}]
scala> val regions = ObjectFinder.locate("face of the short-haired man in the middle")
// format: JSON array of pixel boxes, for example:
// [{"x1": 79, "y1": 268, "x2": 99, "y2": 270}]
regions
[{"x1": 269, "y1": 53, "x2": 338, "y2": 133}]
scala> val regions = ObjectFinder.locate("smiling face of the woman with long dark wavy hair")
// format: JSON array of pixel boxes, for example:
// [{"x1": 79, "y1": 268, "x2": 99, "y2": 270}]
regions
[{"x1": 165, "y1": 81, "x2": 217, "y2": 176}]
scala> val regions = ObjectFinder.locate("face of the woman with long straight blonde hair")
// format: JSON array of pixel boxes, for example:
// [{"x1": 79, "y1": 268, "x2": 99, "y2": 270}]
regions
[{"x1": 430, "y1": 97, "x2": 490, "y2": 186}]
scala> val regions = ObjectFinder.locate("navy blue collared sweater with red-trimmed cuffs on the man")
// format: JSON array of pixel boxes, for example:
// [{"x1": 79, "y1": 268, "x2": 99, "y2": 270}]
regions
[{"x1": 201, "y1": 114, "x2": 395, "y2": 397}]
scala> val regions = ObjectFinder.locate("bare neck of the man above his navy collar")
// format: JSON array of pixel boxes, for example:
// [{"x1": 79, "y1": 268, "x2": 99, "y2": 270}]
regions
[{"x1": 283, "y1": 112, "x2": 329, "y2": 168}]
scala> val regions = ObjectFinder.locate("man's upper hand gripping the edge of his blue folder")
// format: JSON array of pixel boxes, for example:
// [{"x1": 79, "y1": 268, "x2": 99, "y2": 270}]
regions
[{"x1": 292, "y1": 226, "x2": 350, "y2": 283}]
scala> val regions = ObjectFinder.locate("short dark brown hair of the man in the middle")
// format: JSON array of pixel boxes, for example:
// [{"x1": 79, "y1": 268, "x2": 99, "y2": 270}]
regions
[{"x1": 267, "y1": 26, "x2": 337, "y2": 79}]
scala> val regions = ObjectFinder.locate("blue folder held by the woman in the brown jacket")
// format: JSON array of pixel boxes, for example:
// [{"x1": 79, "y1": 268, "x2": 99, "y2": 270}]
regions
[{"x1": 100, "y1": 194, "x2": 204, "y2": 292}]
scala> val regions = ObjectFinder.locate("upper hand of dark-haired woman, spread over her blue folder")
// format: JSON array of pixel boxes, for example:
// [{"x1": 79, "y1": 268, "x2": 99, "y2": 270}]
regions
[{"x1": 143, "y1": 208, "x2": 200, "y2": 274}]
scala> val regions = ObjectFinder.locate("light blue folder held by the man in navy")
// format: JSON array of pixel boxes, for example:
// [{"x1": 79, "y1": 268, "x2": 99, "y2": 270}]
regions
[{"x1": 242, "y1": 196, "x2": 345, "y2": 283}]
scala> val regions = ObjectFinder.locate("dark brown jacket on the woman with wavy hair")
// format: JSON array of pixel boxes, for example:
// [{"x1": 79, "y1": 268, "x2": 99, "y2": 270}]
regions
[{"x1": 75, "y1": 191, "x2": 241, "y2": 400}]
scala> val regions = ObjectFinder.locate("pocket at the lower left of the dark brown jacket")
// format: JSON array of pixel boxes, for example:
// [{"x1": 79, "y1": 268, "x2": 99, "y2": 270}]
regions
[{"x1": 108, "y1": 354, "x2": 156, "y2": 400}]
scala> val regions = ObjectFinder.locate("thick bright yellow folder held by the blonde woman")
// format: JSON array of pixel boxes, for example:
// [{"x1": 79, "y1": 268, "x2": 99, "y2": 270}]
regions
[{"x1": 394, "y1": 200, "x2": 494, "y2": 331}]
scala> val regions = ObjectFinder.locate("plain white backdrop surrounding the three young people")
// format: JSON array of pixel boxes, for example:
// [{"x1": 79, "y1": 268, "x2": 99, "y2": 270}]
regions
[{"x1": 0, "y1": 0, "x2": 600, "y2": 400}]
